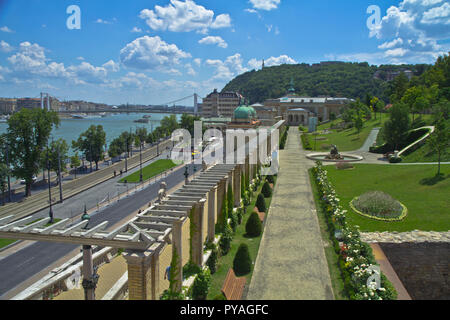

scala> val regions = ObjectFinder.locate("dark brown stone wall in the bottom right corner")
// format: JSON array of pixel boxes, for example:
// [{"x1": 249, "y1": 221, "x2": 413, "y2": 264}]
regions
[{"x1": 379, "y1": 242, "x2": 450, "y2": 300}]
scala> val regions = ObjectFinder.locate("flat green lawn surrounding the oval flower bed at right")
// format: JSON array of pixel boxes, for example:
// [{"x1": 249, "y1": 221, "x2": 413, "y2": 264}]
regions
[{"x1": 325, "y1": 164, "x2": 450, "y2": 232}]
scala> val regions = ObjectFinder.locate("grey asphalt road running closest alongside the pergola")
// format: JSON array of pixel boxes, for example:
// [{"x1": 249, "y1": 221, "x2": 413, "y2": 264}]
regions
[{"x1": 0, "y1": 165, "x2": 201, "y2": 299}]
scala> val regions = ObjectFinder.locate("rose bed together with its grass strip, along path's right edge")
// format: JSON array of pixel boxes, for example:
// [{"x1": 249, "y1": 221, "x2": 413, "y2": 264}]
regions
[{"x1": 310, "y1": 162, "x2": 397, "y2": 300}]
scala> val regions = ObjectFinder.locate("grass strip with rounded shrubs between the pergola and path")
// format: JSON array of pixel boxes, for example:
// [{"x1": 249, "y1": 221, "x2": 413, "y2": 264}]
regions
[{"x1": 207, "y1": 177, "x2": 277, "y2": 300}]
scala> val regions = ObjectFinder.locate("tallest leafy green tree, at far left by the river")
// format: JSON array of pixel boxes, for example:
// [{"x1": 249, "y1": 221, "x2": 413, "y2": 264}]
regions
[{"x1": 7, "y1": 109, "x2": 59, "y2": 197}]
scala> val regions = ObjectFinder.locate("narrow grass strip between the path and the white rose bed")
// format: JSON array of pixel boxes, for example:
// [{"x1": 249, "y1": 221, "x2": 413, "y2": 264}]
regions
[{"x1": 308, "y1": 170, "x2": 349, "y2": 300}]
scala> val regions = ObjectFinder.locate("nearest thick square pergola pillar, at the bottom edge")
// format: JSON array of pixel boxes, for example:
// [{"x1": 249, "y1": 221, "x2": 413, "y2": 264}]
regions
[{"x1": 123, "y1": 251, "x2": 154, "y2": 300}]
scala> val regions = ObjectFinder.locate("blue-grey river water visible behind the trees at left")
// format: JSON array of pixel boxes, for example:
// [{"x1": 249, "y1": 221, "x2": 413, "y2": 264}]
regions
[{"x1": 0, "y1": 113, "x2": 181, "y2": 155}]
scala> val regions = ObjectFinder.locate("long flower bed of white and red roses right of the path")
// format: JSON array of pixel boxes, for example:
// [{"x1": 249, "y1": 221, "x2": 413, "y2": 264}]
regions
[{"x1": 313, "y1": 161, "x2": 397, "y2": 300}]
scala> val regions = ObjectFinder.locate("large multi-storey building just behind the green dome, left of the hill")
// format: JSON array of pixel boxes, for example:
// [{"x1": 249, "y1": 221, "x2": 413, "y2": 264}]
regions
[{"x1": 201, "y1": 89, "x2": 242, "y2": 118}]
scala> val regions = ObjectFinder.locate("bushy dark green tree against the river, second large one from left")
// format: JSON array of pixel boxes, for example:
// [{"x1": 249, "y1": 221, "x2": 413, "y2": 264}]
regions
[{"x1": 72, "y1": 125, "x2": 106, "y2": 170}]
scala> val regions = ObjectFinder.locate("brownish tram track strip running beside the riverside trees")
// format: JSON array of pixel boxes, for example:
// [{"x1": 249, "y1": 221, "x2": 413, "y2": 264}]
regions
[{"x1": 0, "y1": 140, "x2": 172, "y2": 219}]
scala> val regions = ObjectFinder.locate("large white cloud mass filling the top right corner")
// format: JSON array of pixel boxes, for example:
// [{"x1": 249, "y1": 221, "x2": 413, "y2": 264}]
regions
[{"x1": 369, "y1": 0, "x2": 450, "y2": 63}]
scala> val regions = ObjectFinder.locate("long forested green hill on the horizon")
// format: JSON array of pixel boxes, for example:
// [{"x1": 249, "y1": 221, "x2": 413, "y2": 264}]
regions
[{"x1": 222, "y1": 62, "x2": 429, "y2": 103}]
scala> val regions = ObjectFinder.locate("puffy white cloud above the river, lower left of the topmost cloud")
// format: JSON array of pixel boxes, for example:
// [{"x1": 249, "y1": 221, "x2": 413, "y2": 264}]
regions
[{"x1": 120, "y1": 36, "x2": 191, "y2": 71}]
